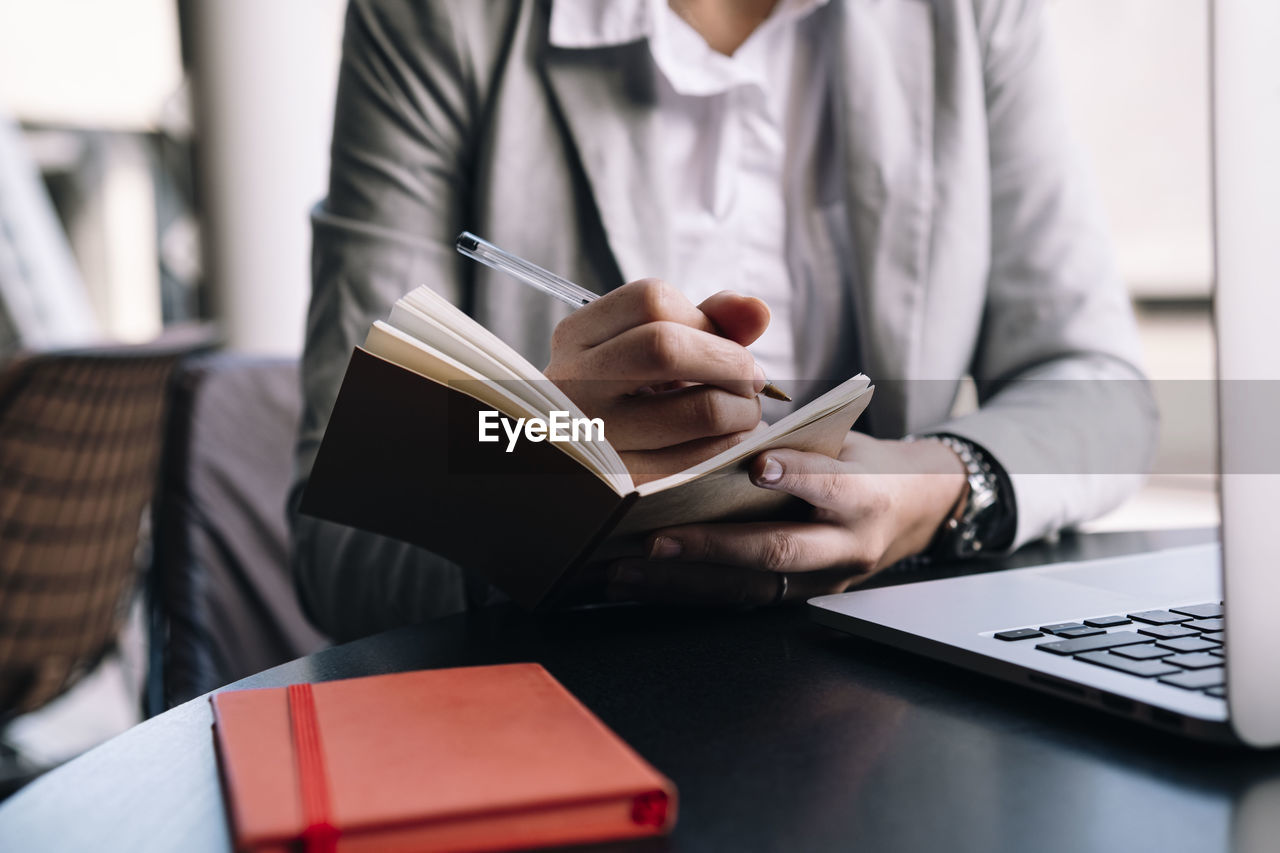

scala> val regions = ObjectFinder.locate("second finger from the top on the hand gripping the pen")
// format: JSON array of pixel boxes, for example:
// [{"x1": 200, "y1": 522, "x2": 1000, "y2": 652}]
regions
[{"x1": 580, "y1": 320, "x2": 764, "y2": 397}]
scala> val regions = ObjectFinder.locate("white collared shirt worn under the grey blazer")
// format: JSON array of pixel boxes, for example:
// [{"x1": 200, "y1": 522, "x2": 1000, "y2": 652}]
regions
[{"x1": 550, "y1": 0, "x2": 851, "y2": 412}]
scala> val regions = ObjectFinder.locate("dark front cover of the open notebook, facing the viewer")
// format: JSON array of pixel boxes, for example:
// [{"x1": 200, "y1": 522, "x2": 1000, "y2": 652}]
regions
[{"x1": 301, "y1": 348, "x2": 635, "y2": 608}]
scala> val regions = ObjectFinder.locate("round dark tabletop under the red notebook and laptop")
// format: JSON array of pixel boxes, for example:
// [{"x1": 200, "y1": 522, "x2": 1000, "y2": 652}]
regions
[{"x1": 0, "y1": 530, "x2": 1280, "y2": 853}]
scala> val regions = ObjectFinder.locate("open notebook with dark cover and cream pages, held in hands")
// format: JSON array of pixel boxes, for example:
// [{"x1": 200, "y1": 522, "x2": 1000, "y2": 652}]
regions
[{"x1": 302, "y1": 287, "x2": 872, "y2": 607}]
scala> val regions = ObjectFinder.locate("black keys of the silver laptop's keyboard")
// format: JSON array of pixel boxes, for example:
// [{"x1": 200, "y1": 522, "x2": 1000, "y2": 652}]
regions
[{"x1": 995, "y1": 602, "x2": 1226, "y2": 698}]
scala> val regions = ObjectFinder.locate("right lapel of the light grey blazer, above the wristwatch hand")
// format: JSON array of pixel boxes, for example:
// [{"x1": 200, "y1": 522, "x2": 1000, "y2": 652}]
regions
[{"x1": 835, "y1": 0, "x2": 933, "y2": 435}]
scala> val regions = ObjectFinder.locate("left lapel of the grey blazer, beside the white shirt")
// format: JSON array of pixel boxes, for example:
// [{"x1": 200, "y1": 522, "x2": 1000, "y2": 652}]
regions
[{"x1": 545, "y1": 41, "x2": 669, "y2": 284}]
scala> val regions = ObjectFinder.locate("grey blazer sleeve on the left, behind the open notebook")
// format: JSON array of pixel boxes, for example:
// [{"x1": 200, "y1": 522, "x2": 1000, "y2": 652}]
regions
[{"x1": 289, "y1": 0, "x2": 506, "y2": 639}]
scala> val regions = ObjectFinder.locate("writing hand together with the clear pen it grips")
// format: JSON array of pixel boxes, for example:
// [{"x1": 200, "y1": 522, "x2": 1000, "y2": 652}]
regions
[{"x1": 457, "y1": 233, "x2": 785, "y2": 480}]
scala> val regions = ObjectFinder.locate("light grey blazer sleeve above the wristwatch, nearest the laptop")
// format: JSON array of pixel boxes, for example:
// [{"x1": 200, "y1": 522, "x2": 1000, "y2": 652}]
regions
[{"x1": 938, "y1": 0, "x2": 1157, "y2": 548}]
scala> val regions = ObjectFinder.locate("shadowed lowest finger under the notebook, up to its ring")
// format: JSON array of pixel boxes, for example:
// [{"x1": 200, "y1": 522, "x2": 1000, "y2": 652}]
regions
[{"x1": 605, "y1": 560, "x2": 780, "y2": 607}]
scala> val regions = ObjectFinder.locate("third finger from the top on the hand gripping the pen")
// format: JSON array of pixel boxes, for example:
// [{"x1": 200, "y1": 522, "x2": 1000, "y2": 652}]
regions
[{"x1": 604, "y1": 386, "x2": 760, "y2": 451}]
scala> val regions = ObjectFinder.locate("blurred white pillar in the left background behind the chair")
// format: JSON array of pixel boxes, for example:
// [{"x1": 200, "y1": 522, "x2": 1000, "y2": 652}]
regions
[{"x1": 188, "y1": 0, "x2": 346, "y2": 355}]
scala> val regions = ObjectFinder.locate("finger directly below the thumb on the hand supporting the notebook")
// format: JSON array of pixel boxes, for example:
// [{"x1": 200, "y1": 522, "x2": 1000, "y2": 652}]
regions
[{"x1": 648, "y1": 521, "x2": 874, "y2": 573}]
